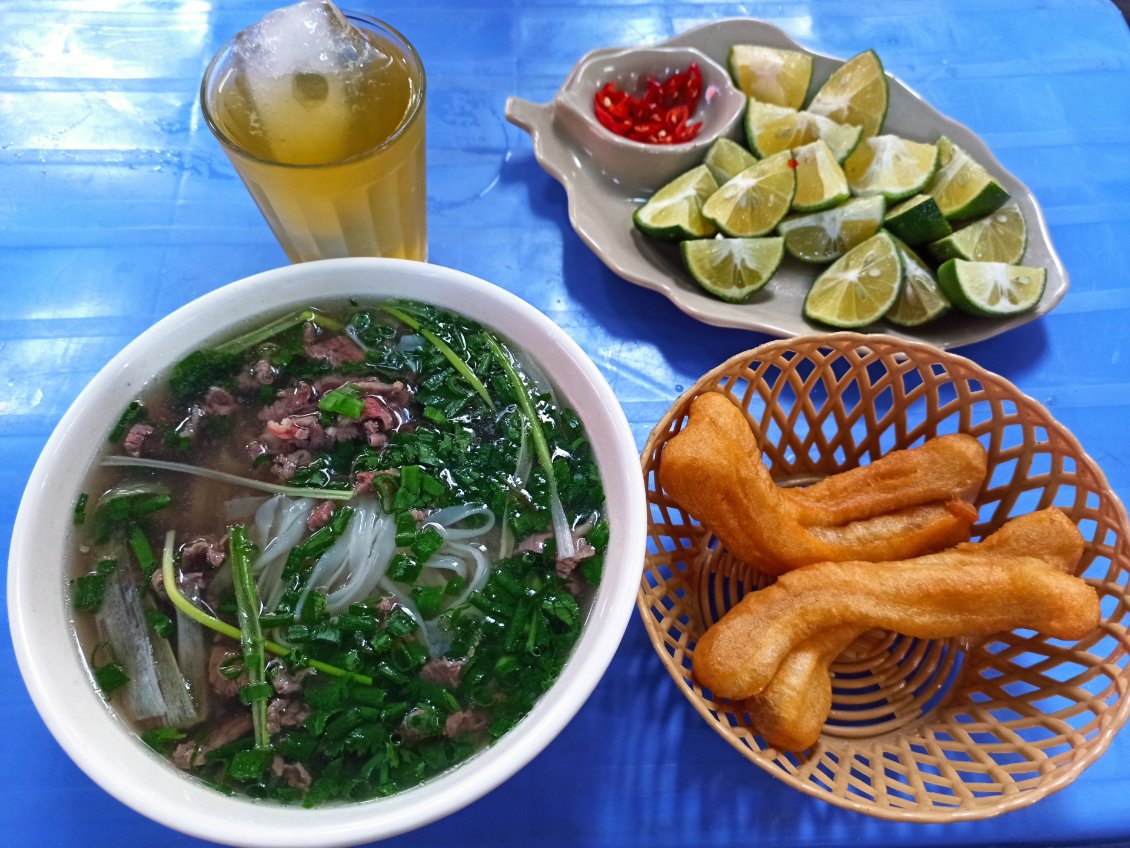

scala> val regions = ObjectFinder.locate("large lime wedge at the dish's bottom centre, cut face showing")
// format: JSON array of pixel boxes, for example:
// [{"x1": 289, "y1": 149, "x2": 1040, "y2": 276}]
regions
[{"x1": 805, "y1": 231, "x2": 903, "y2": 329}]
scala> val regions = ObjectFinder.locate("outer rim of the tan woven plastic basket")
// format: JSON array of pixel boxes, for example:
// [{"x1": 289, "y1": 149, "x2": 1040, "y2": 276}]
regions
[{"x1": 636, "y1": 331, "x2": 1130, "y2": 824}]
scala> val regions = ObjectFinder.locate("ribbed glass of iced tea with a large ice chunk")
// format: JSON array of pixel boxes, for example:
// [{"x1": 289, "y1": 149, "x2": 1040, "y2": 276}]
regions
[{"x1": 200, "y1": 0, "x2": 427, "y2": 262}]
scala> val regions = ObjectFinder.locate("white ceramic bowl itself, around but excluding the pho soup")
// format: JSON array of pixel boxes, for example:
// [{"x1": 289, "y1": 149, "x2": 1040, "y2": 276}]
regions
[{"x1": 8, "y1": 259, "x2": 646, "y2": 848}]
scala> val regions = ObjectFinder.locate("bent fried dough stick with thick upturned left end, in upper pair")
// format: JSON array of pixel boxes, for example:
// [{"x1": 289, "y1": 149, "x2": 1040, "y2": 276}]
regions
[{"x1": 659, "y1": 392, "x2": 983, "y2": 574}]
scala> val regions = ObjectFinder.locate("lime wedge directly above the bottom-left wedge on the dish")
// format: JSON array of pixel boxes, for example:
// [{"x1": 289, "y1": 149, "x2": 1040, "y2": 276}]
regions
[{"x1": 703, "y1": 152, "x2": 797, "y2": 237}]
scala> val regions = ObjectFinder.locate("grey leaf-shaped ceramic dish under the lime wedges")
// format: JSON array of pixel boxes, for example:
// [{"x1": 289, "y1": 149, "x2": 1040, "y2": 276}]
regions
[{"x1": 506, "y1": 18, "x2": 1069, "y2": 348}]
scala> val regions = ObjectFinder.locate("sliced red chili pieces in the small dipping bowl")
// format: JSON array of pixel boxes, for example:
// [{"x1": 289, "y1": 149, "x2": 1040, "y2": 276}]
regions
[{"x1": 593, "y1": 64, "x2": 703, "y2": 144}]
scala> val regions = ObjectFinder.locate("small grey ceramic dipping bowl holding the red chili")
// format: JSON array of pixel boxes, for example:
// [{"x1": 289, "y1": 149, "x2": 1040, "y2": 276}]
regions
[{"x1": 554, "y1": 47, "x2": 746, "y2": 189}]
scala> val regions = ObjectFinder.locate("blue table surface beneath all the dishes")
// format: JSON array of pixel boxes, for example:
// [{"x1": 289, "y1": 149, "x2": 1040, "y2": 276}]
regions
[{"x1": 0, "y1": 0, "x2": 1130, "y2": 848}]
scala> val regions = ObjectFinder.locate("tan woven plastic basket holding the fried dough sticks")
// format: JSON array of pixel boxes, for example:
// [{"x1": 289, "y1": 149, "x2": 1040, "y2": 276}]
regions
[{"x1": 638, "y1": 332, "x2": 1130, "y2": 822}]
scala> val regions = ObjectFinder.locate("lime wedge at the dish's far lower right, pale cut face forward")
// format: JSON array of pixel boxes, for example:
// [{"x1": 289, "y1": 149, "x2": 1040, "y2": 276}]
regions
[{"x1": 938, "y1": 259, "x2": 1048, "y2": 318}]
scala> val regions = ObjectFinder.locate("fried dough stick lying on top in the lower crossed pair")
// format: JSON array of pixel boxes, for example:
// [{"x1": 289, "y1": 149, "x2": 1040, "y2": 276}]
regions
[{"x1": 694, "y1": 533, "x2": 1099, "y2": 700}]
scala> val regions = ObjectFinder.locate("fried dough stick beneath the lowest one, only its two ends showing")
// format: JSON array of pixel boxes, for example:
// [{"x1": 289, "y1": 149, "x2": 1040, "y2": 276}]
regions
[{"x1": 745, "y1": 509, "x2": 1084, "y2": 751}]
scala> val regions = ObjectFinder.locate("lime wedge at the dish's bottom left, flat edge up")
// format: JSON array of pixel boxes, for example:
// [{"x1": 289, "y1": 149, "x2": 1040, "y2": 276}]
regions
[{"x1": 679, "y1": 237, "x2": 784, "y2": 303}]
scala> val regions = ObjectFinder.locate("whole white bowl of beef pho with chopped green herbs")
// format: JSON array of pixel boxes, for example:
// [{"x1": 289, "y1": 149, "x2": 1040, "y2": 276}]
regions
[{"x1": 8, "y1": 259, "x2": 645, "y2": 847}]
